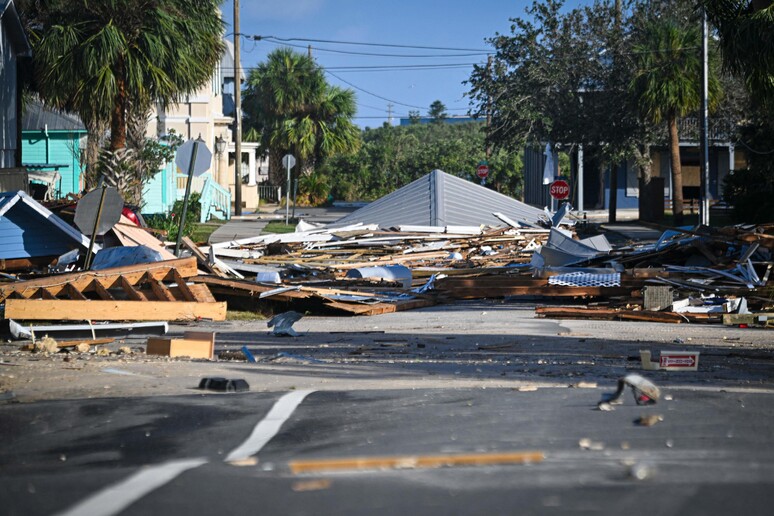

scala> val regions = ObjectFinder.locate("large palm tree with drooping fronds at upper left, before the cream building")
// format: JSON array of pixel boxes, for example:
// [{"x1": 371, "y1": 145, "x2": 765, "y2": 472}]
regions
[{"x1": 32, "y1": 0, "x2": 224, "y2": 151}]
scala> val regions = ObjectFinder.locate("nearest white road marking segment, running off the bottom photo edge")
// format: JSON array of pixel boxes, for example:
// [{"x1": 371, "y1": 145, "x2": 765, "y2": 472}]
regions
[{"x1": 56, "y1": 458, "x2": 207, "y2": 516}]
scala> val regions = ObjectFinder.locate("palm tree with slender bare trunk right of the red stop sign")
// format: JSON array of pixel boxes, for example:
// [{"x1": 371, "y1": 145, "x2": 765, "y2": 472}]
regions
[{"x1": 630, "y1": 18, "x2": 720, "y2": 225}]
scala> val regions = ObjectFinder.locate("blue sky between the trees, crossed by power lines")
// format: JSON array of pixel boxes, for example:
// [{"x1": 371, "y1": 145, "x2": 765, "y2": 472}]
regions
[{"x1": 221, "y1": 0, "x2": 583, "y2": 127}]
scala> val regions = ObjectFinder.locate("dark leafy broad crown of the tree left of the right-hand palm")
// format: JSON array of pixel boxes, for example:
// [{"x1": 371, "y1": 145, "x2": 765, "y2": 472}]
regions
[{"x1": 468, "y1": 0, "x2": 650, "y2": 191}]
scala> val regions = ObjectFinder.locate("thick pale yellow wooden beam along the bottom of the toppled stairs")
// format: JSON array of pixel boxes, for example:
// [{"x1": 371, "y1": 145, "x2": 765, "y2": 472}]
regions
[{"x1": 5, "y1": 299, "x2": 226, "y2": 321}]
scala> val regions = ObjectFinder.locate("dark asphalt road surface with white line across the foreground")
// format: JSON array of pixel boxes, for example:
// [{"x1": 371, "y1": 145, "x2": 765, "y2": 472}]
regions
[{"x1": 0, "y1": 388, "x2": 774, "y2": 516}]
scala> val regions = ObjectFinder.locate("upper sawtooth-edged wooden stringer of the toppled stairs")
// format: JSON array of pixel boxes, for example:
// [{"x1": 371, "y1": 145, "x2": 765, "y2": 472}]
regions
[{"x1": 0, "y1": 256, "x2": 199, "y2": 302}]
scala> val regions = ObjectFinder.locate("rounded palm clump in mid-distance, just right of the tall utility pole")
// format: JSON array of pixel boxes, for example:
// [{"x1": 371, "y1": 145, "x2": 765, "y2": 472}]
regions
[{"x1": 243, "y1": 48, "x2": 359, "y2": 185}]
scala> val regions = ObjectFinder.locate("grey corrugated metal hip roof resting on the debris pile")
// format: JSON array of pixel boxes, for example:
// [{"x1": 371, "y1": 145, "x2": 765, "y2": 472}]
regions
[{"x1": 335, "y1": 170, "x2": 543, "y2": 228}]
